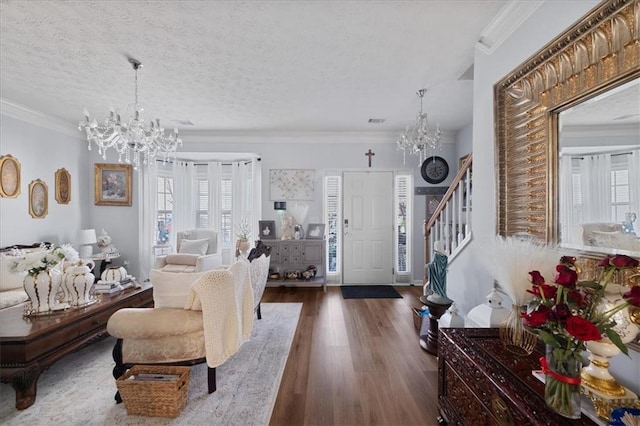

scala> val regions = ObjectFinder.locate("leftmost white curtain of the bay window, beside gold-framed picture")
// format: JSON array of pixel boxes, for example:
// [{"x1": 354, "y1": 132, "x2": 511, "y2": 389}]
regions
[{"x1": 136, "y1": 165, "x2": 159, "y2": 282}]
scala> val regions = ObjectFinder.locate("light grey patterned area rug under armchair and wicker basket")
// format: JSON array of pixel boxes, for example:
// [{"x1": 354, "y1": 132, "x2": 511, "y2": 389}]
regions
[{"x1": 0, "y1": 303, "x2": 302, "y2": 426}]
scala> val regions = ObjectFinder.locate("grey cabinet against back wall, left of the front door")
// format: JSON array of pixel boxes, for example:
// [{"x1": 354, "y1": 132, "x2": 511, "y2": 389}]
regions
[{"x1": 263, "y1": 240, "x2": 327, "y2": 291}]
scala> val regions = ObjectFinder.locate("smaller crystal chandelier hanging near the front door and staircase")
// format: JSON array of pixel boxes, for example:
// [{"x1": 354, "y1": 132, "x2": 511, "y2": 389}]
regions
[{"x1": 396, "y1": 89, "x2": 443, "y2": 165}]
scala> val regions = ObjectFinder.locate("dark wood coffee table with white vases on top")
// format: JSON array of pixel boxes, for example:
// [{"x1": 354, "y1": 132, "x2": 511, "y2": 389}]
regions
[{"x1": 0, "y1": 283, "x2": 153, "y2": 410}]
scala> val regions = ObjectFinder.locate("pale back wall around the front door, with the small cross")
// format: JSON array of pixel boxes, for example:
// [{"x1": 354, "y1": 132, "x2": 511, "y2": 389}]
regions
[{"x1": 183, "y1": 132, "x2": 458, "y2": 282}]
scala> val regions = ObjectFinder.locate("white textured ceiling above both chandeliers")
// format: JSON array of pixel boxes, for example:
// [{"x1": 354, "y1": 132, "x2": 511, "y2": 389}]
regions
[{"x1": 0, "y1": 0, "x2": 507, "y2": 136}]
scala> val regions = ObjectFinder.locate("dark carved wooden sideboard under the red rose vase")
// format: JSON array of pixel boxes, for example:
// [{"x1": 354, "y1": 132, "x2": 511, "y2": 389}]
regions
[{"x1": 438, "y1": 328, "x2": 596, "y2": 426}]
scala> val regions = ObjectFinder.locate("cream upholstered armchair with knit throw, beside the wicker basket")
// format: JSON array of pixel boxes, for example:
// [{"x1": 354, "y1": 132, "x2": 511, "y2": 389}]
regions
[{"x1": 107, "y1": 260, "x2": 255, "y2": 402}]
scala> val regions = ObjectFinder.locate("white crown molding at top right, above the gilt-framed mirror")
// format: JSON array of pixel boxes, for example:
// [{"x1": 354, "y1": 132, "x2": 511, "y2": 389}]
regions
[{"x1": 476, "y1": 0, "x2": 544, "y2": 54}]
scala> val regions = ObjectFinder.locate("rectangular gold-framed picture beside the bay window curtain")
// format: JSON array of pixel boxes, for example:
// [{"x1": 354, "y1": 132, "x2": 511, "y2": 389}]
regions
[{"x1": 94, "y1": 163, "x2": 133, "y2": 206}]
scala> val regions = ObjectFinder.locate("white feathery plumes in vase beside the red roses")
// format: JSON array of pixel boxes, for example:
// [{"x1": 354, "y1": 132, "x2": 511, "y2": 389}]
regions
[{"x1": 481, "y1": 236, "x2": 559, "y2": 306}]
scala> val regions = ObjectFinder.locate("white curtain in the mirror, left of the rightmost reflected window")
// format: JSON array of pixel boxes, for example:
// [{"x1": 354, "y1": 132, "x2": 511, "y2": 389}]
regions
[{"x1": 580, "y1": 154, "x2": 611, "y2": 223}]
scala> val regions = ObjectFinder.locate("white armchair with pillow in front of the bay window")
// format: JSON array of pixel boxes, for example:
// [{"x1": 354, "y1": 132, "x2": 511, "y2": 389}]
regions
[{"x1": 154, "y1": 229, "x2": 222, "y2": 272}]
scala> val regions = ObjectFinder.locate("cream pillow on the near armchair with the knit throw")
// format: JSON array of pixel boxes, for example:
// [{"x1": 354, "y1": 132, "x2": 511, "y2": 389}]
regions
[{"x1": 149, "y1": 269, "x2": 203, "y2": 309}]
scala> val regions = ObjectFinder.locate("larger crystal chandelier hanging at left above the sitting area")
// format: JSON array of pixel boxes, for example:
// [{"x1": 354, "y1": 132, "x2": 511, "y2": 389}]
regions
[{"x1": 78, "y1": 58, "x2": 182, "y2": 170}]
